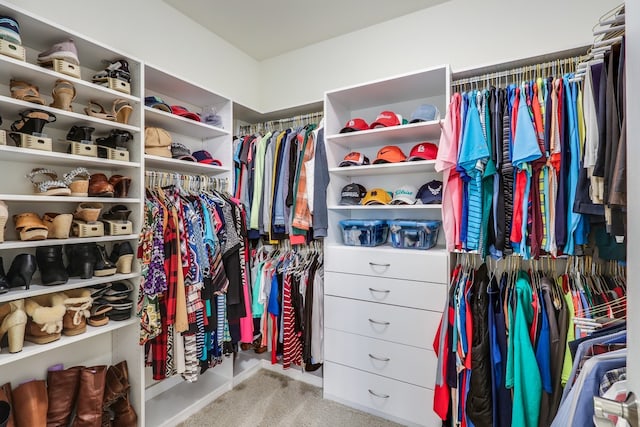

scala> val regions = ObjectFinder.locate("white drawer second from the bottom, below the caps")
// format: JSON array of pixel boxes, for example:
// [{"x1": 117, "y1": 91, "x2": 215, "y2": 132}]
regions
[{"x1": 324, "y1": 329, "x2": 438, "y2": 389}]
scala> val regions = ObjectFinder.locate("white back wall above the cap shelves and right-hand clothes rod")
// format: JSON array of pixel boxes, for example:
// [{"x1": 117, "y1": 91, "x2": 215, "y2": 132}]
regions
[{"x1": 260, "y1": 0, "x2": 622, "y2": 111}]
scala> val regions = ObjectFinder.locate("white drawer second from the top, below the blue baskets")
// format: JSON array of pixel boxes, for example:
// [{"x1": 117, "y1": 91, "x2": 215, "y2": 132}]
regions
[{"x1": 324, "y1": 271, "x2": 447, "y2": 312}]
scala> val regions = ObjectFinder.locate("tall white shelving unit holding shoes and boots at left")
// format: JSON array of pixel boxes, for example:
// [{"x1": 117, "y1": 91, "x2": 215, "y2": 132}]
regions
[{"x1": 0, "y1": 0, "x2": 144, "y2": 422}]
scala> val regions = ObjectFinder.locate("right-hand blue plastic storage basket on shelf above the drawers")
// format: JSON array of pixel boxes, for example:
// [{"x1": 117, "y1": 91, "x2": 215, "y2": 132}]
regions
[{"x1": 388, "y1": 219, "x2": 442, "y2": 249}]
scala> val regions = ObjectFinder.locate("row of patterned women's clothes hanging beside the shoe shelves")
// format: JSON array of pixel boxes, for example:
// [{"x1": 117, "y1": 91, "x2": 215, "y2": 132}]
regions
[{"x1": 137, "y1": 171, "x2": 253, "y2": 382}]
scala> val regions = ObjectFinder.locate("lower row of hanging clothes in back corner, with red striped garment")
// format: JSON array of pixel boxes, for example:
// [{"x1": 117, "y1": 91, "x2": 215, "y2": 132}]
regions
[{"x1": 247, "y1": 241, "x2": 324, "y2": 371}]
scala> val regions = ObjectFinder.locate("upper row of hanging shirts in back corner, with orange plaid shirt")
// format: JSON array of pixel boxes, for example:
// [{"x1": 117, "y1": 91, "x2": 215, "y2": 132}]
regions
[{"x1": 233, "y1": 113, "x2": 329, "y2": 244}]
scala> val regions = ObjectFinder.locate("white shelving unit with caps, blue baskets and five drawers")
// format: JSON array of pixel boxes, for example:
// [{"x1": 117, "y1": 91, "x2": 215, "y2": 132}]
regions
[{"x1": 323, "y1": 66, "x2": 450, "y2": 426}]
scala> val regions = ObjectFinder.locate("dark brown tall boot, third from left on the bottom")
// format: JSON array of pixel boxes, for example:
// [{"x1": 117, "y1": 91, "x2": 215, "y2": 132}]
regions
[{"x1": 47, "y1": 366, "x2": 82, "y2": 427}]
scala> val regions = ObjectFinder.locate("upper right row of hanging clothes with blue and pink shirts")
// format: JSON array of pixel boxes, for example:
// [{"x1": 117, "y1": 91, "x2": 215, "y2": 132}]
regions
[{"x1": 436, "y1": 37, "x2": 626, "y2": 260}]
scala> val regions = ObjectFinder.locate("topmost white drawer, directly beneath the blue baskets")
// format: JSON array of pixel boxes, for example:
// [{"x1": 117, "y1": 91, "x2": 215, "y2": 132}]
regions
[{"x1": 325, "y1": 245, "x2": 449, "y2": 283}]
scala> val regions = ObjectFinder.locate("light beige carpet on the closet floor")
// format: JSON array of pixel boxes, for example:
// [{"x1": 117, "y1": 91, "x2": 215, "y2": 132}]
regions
[{"x1": 179, "y1": 369, "x2": 400, "y2": 427}]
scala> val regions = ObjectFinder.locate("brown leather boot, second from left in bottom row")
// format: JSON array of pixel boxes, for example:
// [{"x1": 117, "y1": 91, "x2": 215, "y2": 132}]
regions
[{"x1": 11, "y1": 380, "x2": 48, "y2": 427}]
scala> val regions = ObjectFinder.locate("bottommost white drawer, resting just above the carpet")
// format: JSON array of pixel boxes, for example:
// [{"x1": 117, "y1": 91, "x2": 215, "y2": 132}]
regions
[{"x1": 323, "y1": 362, "x2": 442, "y2": 427}]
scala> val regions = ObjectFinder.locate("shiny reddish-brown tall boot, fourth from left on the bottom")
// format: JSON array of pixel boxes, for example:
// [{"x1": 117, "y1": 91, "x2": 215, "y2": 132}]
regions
[{"x1": 73, "y1": 365, "x2": 107, "y2": 427}]
